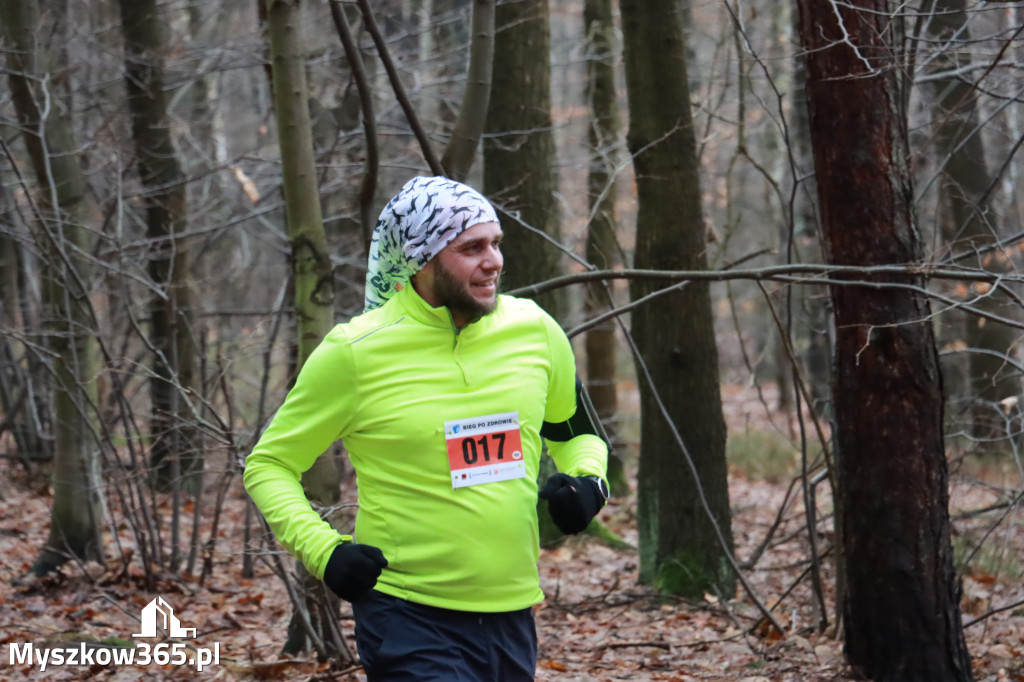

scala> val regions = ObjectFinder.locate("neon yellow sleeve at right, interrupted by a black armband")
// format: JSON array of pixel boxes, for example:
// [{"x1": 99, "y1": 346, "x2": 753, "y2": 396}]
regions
[{"x1": 544, "y1": 314, "x2": 608, "y2": 478}]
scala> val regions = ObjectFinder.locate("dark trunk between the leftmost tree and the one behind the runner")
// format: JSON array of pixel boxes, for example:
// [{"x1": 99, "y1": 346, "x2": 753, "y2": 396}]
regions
[{"x1": 120, "y1": 0, "x2": 203, "y2": 493}]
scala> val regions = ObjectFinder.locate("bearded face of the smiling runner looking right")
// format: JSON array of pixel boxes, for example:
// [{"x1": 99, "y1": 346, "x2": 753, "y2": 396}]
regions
[{"x1": 414, "y1": 222, "x2": 504, "y2": 328}]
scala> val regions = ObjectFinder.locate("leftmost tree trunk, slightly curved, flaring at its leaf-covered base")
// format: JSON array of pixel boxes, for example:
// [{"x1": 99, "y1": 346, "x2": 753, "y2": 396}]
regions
[{"x1": 0, "y1": 0, "x2": 103, "y2": 574}]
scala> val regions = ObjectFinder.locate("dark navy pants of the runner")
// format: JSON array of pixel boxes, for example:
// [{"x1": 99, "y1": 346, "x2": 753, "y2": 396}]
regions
[{"x1": 352, "y1": 590, "x2": 537, "y2": 682}]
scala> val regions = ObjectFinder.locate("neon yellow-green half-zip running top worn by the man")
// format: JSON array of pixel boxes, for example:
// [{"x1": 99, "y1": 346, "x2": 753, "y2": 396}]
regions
[{"x1": 244, "y1": 286, "x2": 607, "y2": 611}]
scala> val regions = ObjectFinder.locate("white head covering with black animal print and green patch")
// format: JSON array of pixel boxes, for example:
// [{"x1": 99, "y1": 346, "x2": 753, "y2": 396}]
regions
[{"x1": 364, "y1": 177, "x2": 498, "y2": 311}]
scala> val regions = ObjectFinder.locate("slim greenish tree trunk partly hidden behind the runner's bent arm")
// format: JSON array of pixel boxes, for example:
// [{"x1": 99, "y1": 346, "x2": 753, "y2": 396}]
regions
[{"x1": 266, "y1": 0, "x2": 344, "y2": 654}]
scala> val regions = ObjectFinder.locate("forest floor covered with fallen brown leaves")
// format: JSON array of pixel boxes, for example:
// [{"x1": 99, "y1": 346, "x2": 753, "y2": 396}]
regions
[{"x1": 0, "y1": 385, "x2": 1024, "y2": 682}]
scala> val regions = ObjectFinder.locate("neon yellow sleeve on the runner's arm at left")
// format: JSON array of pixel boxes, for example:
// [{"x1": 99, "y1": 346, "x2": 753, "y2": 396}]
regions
[{"x1": 243, "y1": 328, "x2": 358, "y2": 580}]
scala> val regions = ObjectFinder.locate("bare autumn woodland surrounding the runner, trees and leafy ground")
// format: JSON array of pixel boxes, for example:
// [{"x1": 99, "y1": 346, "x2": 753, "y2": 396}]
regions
[{"x1": 0, "y1": 0, "x2": 1024, "y2": 680}]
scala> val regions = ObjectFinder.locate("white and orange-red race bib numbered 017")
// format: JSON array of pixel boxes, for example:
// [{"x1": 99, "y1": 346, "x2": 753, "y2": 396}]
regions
[{"x1": 444, "y1": 412, "x2": 526, "y2": 487}]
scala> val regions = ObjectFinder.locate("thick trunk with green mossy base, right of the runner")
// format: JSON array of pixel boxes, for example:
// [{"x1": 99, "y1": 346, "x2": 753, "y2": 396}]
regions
[{"x1": 621, "y1": 0, "x2": 735, "y2": 597}]
